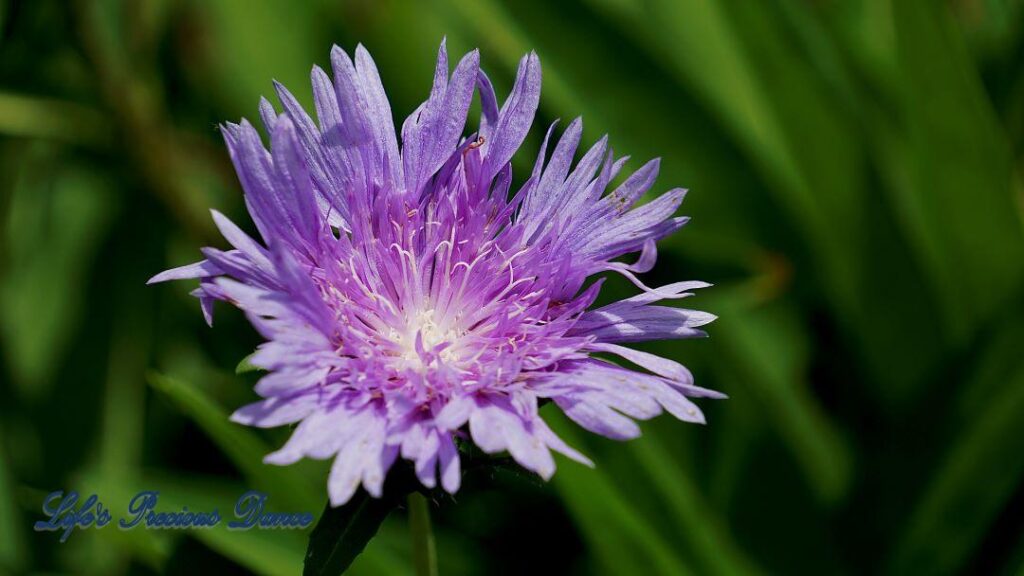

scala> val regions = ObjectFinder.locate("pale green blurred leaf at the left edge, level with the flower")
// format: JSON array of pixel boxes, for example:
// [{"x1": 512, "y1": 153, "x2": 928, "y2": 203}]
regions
[{"x1": 0, "y1": 147, "x2": 114, "y2": 398}]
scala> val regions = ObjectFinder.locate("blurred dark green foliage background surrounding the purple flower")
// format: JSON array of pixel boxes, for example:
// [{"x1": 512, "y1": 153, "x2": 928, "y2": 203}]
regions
[{"x1": 0, "y1": 0, "x2": 1024, "y2": 576}]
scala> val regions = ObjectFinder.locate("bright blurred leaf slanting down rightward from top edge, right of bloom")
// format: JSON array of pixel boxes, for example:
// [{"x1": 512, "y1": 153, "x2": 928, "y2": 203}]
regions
[{"x1": 592, "y1": 0, "x2": 863, "y2": 321}]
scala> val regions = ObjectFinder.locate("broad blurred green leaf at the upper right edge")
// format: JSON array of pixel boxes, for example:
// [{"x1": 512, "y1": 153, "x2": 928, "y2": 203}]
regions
[{"x1": 892, "y1": 0, "x2": 1024, "y2": 343}]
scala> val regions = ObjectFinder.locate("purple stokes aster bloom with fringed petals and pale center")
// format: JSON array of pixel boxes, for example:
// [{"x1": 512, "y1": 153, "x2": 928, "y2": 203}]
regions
[{"x1": 151, "y1": 44, "x2": 723, "y2": 505}]
